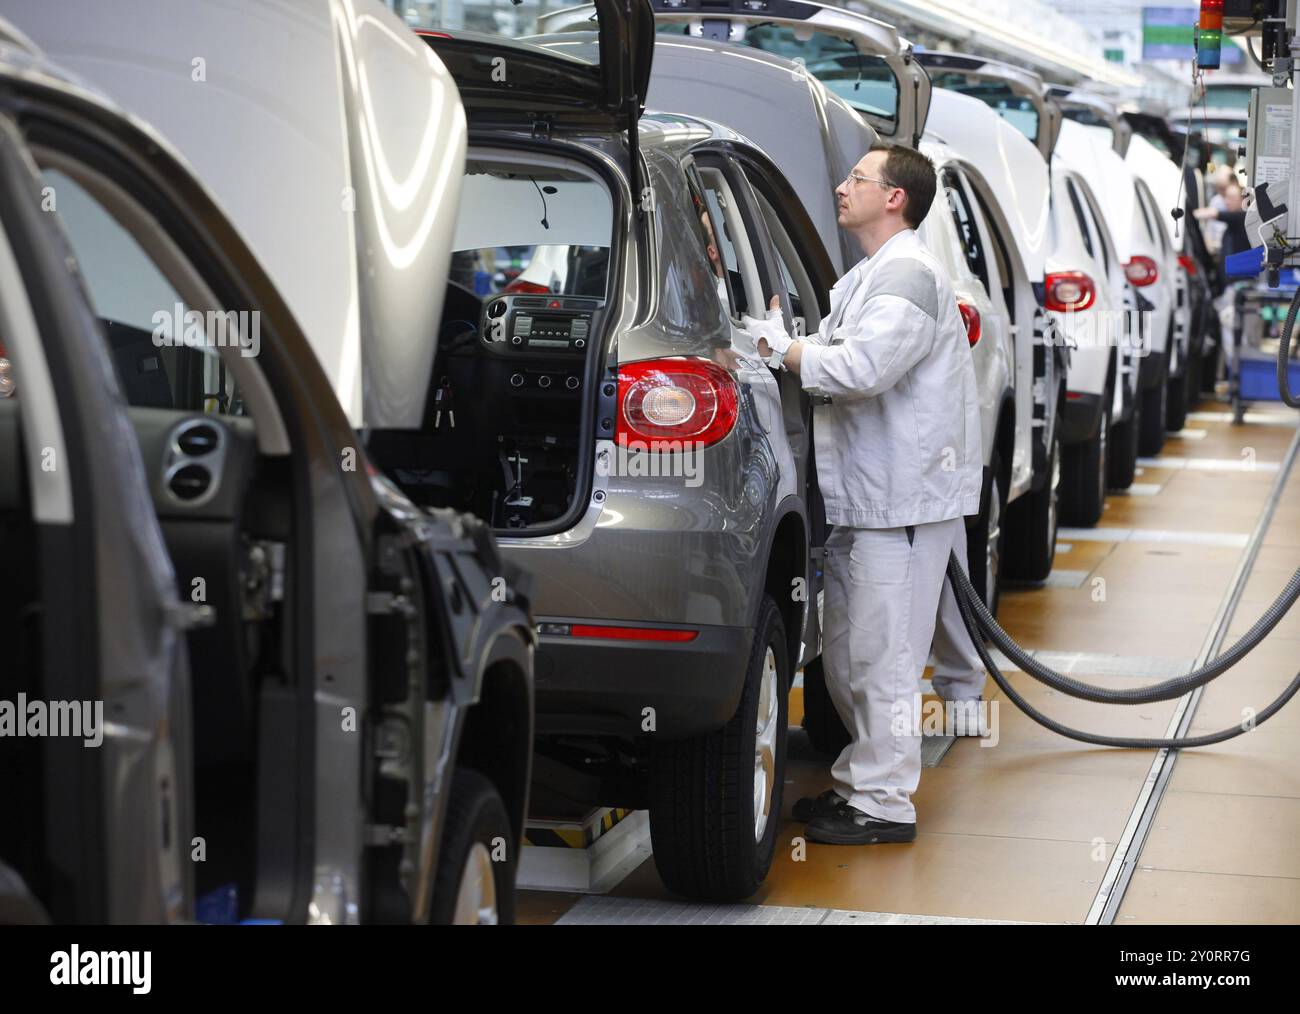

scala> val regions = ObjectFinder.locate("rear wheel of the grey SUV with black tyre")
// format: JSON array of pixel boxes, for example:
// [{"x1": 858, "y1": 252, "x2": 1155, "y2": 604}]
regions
[{"x1": 650, "y1": 595, "x2": 790, "y2": 901}]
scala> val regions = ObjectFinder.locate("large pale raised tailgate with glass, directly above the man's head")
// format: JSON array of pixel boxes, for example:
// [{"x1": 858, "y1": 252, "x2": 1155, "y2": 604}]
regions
[{"x1": 537, "y1": 0, "x2": 930, "y2": 147}]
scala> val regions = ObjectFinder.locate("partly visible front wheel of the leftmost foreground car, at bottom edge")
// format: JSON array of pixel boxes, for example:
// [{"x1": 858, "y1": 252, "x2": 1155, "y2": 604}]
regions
[{"x1": 429, "y1": 768, "x2": 517, "y2": 926}]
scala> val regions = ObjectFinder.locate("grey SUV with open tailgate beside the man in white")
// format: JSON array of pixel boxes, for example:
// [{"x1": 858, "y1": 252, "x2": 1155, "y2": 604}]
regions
[{"x1": 400, "y1": 0, "x2": 835, "y2": 898}]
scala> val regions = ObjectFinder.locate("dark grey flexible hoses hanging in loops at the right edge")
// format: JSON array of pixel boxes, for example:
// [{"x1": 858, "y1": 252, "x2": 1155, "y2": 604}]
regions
[{"x1": 948, "y1": 297, "x2": 1300, "y2": 750}]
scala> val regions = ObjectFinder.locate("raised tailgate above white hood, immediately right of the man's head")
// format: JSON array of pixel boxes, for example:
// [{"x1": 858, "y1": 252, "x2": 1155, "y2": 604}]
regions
[{"x1": 917, "y1": 52, "x2": 1061, "y2": 165}]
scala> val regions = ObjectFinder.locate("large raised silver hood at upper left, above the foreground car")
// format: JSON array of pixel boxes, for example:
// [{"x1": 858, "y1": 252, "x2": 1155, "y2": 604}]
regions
[{"x1": 5, "y1": 0, "x2": 465, "y2": 425}]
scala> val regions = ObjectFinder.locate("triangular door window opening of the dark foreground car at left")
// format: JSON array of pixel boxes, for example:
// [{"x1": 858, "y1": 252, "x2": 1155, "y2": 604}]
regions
[{"x1": 42, "y1": 169, "x2": 249, "y2": 415}]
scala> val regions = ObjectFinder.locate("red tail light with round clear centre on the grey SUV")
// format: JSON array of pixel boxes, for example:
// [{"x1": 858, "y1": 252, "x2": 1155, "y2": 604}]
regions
[{"x1": 615, "y1": 356, "x2": 738, "y2": 446}]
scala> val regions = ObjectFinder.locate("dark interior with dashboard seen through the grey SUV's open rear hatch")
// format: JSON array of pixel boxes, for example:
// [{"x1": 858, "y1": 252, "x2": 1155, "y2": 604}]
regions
[{"x1": 367, "y1": 152, "x2": 614, "y2": 534}]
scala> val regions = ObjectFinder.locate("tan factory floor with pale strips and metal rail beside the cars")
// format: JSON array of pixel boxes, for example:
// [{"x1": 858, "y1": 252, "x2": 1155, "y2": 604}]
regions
[{"x1": 519, "y1": 400, "x2": 1300, "y2": 924}]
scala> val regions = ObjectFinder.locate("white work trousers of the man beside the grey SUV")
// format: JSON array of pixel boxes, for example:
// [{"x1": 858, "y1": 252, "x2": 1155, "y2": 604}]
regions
[{"x1": 822, "y1": 517, "x2": 984, "y2": 823}]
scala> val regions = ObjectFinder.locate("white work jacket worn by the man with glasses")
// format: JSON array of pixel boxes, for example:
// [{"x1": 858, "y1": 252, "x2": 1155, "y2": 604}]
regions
[{"x1": 800, "y1": 229, "x2": 983, "y2": 528}]
